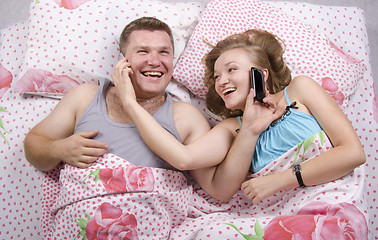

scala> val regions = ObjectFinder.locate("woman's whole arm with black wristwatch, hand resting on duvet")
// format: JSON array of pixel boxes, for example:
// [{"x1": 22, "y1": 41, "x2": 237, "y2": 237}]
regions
[{"x1": 242, "y1": 76, "x2": 366, "y2": 204}]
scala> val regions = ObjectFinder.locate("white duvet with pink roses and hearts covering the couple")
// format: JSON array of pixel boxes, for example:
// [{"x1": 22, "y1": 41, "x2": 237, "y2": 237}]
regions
[{"x1": 42, "y1": 132, "x2": 368, "y2": 239}]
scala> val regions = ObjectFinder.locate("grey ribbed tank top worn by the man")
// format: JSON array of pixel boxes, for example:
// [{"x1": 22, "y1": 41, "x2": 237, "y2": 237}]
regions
[{"x1": 75, "y1": 78, "x2": 181, "y2": 170}]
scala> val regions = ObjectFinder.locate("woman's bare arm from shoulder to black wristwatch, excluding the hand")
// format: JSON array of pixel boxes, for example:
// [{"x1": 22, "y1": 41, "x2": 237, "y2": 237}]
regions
[{"x1": 288, "y1": 76, "x2": 366, "y2": 183}]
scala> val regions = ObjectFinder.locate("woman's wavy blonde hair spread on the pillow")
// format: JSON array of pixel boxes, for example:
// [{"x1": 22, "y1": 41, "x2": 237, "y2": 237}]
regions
[{"x1": 204, "y1": 29, "x2": 291, "y2": 118}]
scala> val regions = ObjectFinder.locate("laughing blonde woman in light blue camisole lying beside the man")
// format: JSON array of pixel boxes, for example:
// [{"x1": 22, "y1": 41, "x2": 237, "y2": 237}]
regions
[{"x1": 114, "y1": 30, "x2": 365, "y2": 204}]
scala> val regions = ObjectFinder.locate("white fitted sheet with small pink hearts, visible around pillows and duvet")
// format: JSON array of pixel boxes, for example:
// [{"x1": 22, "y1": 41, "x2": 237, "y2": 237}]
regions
[{"x1": 0, "y1": 2, "x2": 378, "y2": 239}]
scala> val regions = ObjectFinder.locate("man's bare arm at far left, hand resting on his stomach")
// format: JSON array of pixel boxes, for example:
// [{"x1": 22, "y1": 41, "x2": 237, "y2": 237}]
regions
[{"x1": 24, "y1": 84, "x2": 107, "y2": 171}]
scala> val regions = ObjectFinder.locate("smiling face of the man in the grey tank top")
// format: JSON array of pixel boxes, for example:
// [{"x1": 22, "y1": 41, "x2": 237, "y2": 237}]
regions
[{"x1": 125, "y1": 30, "x2": 173, "y2": 98}]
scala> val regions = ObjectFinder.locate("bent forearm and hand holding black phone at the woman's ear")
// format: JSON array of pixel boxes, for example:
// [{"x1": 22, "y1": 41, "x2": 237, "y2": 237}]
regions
[{"x1": 191, "y1": 91, "x2": 285, "y2": 202}]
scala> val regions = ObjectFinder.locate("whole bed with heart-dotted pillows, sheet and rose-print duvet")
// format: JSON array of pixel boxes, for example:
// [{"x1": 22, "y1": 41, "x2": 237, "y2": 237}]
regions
[{"x1": 0, "y1": 0, "x2": 378, "y2": 239}]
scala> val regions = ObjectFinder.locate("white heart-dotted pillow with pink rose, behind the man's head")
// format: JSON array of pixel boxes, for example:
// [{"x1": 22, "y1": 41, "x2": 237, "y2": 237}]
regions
[{"x1": 12, "y1": 0, "x2": 205, "y2": 94}]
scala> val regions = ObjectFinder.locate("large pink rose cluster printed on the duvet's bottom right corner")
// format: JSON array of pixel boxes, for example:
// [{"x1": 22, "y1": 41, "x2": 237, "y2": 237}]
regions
[{"x1": 264, "y1": 202, "x2": 367, "y2": 240}]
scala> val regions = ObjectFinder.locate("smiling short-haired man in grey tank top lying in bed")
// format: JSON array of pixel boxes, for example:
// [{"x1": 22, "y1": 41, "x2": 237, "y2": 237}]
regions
[{"x1": 24, "y1": 17, "x2": 221, "y2": 171}]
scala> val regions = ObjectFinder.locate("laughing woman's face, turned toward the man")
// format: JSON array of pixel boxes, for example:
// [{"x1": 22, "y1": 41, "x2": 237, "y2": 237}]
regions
[{"x1": 214, "y1": 48, "x2": 253, "y2": 111}]
